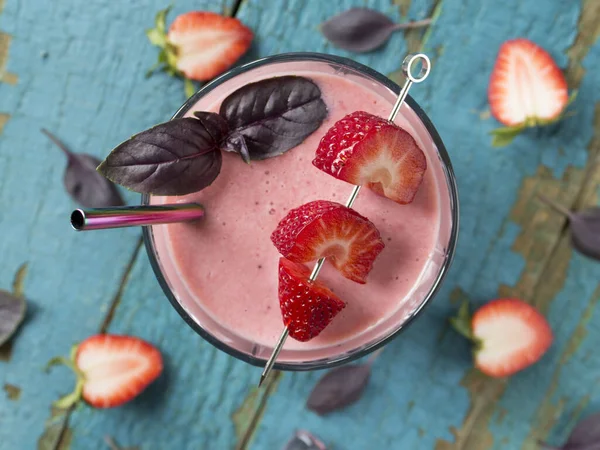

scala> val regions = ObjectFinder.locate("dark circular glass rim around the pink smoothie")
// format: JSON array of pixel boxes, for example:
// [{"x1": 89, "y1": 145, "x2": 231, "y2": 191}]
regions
[{"x1": 141, "y1": 52, "x2": 459, "y2": 372}]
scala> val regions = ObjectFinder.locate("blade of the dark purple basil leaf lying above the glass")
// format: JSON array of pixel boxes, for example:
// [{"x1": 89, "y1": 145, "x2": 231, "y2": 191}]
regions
[{"x1": 321, "y1": 8, "x2": 396, "y2": 53}]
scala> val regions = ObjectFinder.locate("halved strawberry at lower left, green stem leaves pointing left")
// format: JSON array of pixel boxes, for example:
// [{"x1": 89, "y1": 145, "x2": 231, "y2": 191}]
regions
[{"x1": 48, "y1": 334, "x2": 163, "y2": 409}]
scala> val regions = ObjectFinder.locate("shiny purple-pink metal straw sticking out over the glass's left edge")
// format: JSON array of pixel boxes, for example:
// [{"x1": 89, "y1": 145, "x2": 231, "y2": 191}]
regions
[{"x1": 71, "y1": 203, "x2": 204, "y2": 231}]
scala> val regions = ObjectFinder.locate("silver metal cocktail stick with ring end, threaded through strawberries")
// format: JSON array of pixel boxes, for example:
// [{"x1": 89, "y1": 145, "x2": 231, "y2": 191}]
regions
[{"x1": 258, "y1": 53, "x2": 431, "y2": 387}]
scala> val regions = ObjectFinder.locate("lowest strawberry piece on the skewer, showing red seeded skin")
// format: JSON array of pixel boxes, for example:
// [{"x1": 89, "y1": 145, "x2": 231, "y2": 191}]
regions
[{"x1": 279, "y1": 258, "x2": 346, "y2": 342}]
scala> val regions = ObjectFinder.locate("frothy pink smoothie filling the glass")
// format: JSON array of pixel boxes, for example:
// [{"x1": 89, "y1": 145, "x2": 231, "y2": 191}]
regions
[{"x1": 152, "y1": 60, "x2": 448, "y2": 361}]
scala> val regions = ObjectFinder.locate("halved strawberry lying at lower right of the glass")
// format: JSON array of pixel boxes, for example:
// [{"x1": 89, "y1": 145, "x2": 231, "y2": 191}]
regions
[{"x1": 451, "y1": 298, "x2": 553, "y2": 377}]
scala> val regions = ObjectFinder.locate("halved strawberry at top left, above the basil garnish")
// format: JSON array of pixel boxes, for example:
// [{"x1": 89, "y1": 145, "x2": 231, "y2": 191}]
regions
[{"x1": 146, "y1": 8, "x2": 253, "y2": 89}]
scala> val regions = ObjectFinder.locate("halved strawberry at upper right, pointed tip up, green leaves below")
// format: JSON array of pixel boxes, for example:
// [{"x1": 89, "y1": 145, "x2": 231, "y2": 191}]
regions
[{"x1": 488, "y1": 38, "x2": 569, "y2": 145}]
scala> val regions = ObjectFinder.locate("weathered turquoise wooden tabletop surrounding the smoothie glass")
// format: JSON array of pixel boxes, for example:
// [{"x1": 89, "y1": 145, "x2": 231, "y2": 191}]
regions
[{"x1": 0, "y1": 0, "x2": 600, "y2": 450}]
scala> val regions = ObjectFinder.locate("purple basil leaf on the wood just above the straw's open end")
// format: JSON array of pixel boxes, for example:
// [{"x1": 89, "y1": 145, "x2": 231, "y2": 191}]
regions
[{"x1": 42, "y1": 129, "x2": 123, "y2": 208}]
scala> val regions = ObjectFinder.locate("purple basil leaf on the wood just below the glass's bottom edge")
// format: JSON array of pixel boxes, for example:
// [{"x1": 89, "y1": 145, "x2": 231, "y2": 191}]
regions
[{"x1": 306, "y1": 363, "x2": 371, "y2": 415}]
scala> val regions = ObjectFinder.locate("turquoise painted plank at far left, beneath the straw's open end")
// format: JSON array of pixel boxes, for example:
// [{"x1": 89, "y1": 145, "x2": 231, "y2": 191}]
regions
[{"x1": 0, "y1": 0, "x2": 232, "y2": 449}]
